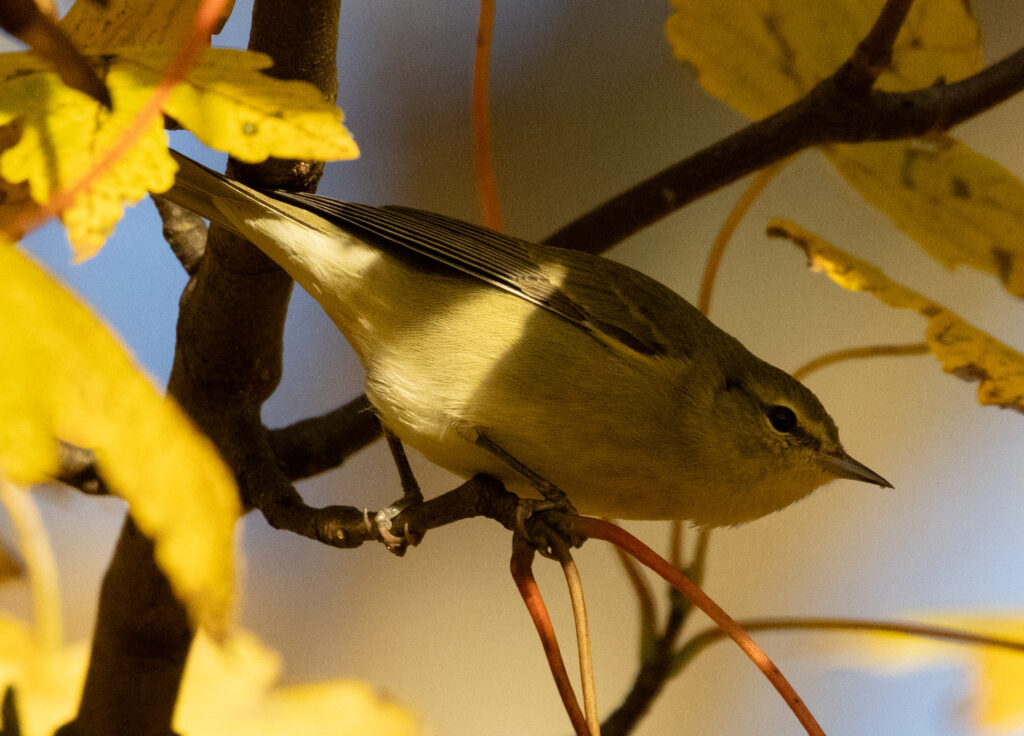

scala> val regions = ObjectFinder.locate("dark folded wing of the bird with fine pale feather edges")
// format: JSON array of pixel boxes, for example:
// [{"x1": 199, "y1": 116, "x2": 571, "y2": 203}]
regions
[{"x1": 268, "y1": 191, "x2": 714, "y2": 356}]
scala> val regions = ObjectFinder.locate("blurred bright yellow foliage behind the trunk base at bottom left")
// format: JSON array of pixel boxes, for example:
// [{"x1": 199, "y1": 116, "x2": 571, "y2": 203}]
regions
[{"x1": 0, "y1": 614, "x2": 423, "y2": 736}]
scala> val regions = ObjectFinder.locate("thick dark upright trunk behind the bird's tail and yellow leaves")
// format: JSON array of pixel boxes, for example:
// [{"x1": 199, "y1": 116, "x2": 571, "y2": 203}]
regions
[{"x1": 61, "y1": 0, "x2": 340, "y2": 736}]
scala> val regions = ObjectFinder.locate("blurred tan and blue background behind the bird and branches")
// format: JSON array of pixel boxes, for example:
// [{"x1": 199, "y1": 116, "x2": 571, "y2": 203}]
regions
[{"x1": 8, "y1": 0, "x2": 1024, "y2": 736}]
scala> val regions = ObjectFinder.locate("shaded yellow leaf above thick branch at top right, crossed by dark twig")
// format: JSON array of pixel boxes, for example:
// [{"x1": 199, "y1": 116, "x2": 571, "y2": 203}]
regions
[{"x1": 667, "y1": 0, "x2": 981, "y2": 119}]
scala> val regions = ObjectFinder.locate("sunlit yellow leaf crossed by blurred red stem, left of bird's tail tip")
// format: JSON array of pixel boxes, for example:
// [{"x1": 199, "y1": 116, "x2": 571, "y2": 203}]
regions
[{"x1": 0, "y1": 57, "x2": 175, "y2": 258}]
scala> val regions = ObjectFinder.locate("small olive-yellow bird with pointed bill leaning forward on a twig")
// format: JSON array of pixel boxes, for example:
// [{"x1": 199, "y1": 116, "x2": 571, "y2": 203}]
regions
[{"x1": 157, "y1": 150, "x2": 892, "y2": 527}]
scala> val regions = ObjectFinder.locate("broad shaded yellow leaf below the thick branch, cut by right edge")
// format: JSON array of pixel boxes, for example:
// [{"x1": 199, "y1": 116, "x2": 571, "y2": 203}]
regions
[{"x1": 825, "y1": 136, "x2": 1024, "y2": 297}]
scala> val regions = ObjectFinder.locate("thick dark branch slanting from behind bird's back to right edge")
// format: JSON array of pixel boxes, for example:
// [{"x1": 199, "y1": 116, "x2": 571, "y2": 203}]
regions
[{"x1": 545, "y1": 44, "x2": 1024, "y2": 253}]
